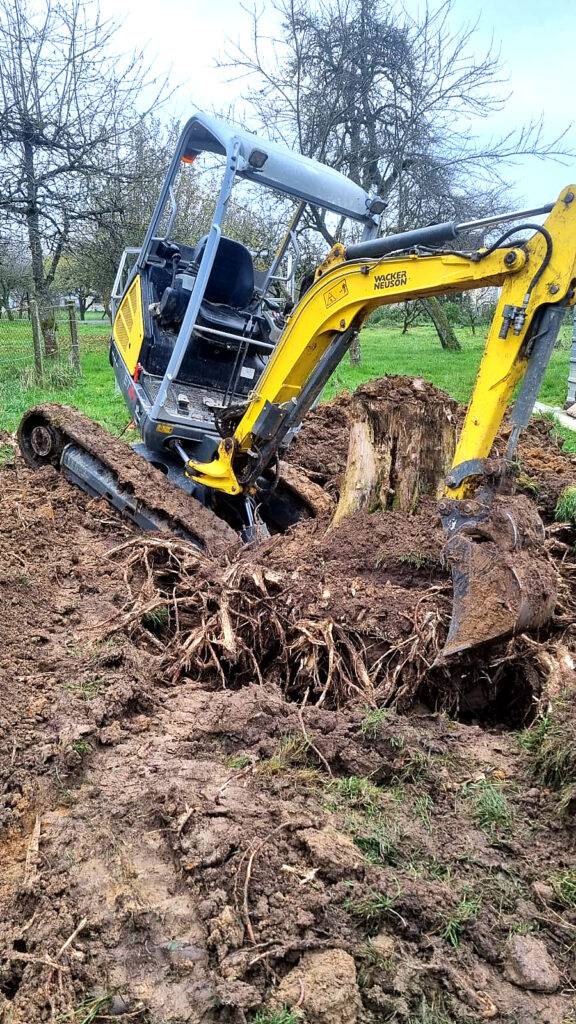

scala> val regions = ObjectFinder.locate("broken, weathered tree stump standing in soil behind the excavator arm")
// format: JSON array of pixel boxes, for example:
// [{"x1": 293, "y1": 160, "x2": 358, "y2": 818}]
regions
[{"x1": 332, "y1": 377, "x2": 457, "y2": 525}]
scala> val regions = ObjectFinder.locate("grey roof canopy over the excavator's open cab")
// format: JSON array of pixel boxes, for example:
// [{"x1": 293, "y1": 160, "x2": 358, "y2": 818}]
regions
[{"x1": 180, "y1": 112, "x2": 374, "y2": 221}]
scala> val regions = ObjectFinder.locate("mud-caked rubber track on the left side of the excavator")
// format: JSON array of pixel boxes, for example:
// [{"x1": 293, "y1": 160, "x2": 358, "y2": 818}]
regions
[{"x1": 18, "y1": 402, "x2": 241, "y2": 555}]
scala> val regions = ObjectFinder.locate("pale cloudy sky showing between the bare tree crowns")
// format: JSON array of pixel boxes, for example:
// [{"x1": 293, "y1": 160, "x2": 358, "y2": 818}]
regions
[{"x1": 100, "y1": 0, "x2": 576, "y2": 205}]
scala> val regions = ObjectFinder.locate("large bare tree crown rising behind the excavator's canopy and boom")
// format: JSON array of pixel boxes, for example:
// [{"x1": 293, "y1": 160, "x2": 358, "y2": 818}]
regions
[{"x1": 220, "y1": 0, "x2": 568, "y2": 348}]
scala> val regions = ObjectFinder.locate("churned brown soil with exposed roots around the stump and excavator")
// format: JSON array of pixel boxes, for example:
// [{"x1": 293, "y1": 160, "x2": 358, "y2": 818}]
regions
[{"x1": 0, "y1": 381, "x2": 576, "y2": 1024}]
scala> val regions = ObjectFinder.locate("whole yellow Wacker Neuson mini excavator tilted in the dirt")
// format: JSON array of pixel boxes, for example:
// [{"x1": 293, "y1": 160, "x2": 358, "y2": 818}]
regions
[{"x1": 15, "y1": 114, "x2": 576, "y2": 656}]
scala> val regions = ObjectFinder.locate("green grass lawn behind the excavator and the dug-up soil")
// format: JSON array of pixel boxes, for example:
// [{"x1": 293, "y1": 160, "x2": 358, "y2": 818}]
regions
[{"x1": 0, "y1": 319, "x2": 576, "y2": 452}]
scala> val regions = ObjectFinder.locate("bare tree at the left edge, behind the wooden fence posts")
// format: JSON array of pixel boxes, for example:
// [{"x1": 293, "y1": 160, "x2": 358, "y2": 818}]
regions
[{"x1": 0, "y1": 0, "x2": 163, "y2": 354}]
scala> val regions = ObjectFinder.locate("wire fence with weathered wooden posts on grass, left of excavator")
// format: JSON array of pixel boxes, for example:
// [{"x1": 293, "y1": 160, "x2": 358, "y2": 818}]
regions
[{"x1": 0, "y1": 302, "x2": 110, "y2": 389}]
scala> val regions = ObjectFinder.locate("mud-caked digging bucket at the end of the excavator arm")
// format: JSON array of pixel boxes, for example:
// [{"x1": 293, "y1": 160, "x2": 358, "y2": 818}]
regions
[{"x1": 439, "y1": 496, "x2": 558, "y2": 660}]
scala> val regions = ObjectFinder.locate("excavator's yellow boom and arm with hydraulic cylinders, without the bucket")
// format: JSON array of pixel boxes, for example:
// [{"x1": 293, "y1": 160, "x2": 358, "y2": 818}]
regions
[{"x1": 188, "y1": 192, "x2": 576, "y2": 498}]
